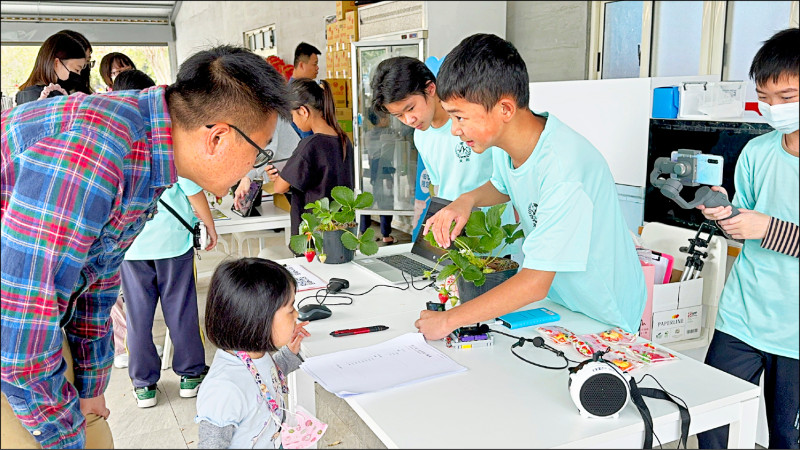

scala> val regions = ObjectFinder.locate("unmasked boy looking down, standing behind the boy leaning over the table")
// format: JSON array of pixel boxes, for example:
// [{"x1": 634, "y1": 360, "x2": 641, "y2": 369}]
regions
[{"x1": 370, "y1": 56, "x2": 520, "y2": 255}]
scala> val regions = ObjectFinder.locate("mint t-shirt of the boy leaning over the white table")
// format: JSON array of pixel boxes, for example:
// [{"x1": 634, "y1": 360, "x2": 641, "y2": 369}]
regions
[{"x1": 492, "y1": 113, "x2": 647, "y2": 332}]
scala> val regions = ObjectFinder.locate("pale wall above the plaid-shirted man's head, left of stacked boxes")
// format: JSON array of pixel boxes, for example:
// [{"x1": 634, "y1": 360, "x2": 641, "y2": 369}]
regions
[{"x1": 175, "y1": 1, "x2": 336, "y2": 68}]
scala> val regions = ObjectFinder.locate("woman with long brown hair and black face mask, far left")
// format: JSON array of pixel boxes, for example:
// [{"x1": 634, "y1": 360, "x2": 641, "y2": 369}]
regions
[{"x1": 15, "y1": 33, "x2": 88, "y2": 105}]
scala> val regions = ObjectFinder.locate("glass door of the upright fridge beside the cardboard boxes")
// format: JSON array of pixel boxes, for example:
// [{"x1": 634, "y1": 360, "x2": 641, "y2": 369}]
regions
[{"x1": 351, "y1": 39, "x2": 424, "y2": 216}]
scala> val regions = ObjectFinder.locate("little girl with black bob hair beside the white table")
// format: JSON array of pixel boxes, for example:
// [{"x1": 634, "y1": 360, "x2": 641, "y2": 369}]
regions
[{"x1": 195, "y1": 258, "x2": 309, "y2": 448}]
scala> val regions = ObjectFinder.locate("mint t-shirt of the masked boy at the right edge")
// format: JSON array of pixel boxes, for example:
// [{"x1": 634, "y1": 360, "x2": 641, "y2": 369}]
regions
[{"x1": 715, "y1": 131, "x2": 800, "y2": 359}]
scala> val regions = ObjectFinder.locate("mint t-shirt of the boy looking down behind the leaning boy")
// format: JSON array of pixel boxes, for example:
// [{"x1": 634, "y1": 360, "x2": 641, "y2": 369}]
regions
[{"x1": 414, "y1": 119, "x2": 521, "y2": 255}]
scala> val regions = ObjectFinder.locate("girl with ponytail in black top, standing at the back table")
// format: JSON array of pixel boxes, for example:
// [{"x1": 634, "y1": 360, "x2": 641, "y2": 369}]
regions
[{"x1": 266, "y1": 78, "x2": 355, "y2": 251}]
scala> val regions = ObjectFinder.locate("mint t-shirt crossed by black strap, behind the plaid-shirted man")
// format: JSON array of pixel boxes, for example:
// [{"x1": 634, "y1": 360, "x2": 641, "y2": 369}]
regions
[{"x1": 125, "y1": 177, "x2": 203, "y2": 260}]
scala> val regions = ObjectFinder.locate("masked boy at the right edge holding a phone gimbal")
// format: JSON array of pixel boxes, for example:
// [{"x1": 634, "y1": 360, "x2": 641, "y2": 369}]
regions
[{"x1": 697, "y1": 28, "x2": 800, "y2": 448}]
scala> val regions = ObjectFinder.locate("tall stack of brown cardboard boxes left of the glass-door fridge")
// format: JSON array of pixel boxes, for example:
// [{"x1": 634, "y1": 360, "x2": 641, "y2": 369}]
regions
[{"x1": 325, "y1": 1, "x2": 358, "y2": 141}]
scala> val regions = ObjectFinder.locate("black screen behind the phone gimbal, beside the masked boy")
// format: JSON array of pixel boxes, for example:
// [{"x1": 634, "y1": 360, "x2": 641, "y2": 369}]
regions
[{"x1": 644, "y1": 119, "x2": 772, "y2": 229}]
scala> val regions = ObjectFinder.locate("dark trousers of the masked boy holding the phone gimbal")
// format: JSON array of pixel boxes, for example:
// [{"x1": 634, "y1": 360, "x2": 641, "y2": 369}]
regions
[{"x1": 697, "y1": 330, "x2": 800, "y2": 448}]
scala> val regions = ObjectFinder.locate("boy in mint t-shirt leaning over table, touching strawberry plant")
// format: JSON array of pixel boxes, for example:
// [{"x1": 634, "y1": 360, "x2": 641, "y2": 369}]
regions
[{"x1": 415, "y1": 34, "x2": 647, "y2": 339}]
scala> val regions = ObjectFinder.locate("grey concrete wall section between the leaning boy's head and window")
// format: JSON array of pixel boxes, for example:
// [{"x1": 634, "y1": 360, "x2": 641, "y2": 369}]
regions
[{"x1": 506, "y1": 1, "x2": 590, "y2": 82}]
